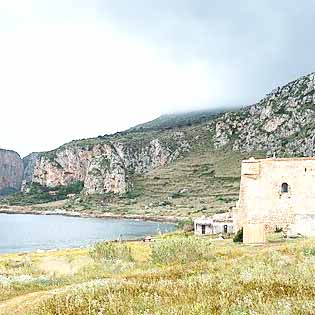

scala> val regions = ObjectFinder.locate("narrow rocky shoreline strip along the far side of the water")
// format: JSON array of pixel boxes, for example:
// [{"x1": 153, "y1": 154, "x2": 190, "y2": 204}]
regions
[{"x1": 0, "y1": 206, "x2": 186, "y2": 224}]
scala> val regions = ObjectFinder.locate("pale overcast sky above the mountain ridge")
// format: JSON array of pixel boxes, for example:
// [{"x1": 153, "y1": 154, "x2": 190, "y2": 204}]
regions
[{"x1": 0, "y1": 0, "x2": 315, "y2": 156}]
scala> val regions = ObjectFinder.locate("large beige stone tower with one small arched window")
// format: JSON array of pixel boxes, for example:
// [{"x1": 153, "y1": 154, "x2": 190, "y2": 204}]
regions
[{"x1": 233, "y1": 157, "x2": 315, "y2": 241}]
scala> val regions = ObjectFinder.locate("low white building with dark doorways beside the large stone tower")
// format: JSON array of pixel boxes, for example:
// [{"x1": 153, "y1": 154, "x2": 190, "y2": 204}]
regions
[{"x1": 194, "y1": 214, "x2": 233, "y2": 235}]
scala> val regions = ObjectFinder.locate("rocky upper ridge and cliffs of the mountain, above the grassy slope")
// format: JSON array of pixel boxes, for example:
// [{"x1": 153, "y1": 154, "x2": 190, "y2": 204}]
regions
[{"x1": 0, "y1": 73, "x2": 315, "y2": 198}]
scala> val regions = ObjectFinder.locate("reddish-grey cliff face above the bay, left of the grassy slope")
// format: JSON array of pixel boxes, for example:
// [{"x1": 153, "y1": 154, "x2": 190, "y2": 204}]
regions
[{"x1": 31, "y1": 132, "x2": 189, "y2": 194}]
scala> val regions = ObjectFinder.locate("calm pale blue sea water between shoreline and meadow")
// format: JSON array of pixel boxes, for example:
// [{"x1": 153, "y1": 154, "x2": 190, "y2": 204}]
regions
[{"x1": 0, "y1": 214, "x2": 175, "y2": 253}]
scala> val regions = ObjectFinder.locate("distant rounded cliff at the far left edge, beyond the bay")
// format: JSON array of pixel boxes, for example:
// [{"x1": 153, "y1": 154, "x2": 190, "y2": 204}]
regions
[{"x1": 0, "y1": 149, "x2": 23, "y2": 195}]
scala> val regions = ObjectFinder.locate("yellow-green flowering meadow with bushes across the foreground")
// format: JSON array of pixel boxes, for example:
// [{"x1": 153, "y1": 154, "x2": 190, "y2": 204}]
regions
[{"x1": 0, "y1": 233, "x2": 315, "y2": 315}]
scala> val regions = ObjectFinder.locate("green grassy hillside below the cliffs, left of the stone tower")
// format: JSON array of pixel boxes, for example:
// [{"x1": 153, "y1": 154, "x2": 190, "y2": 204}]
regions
[{"x1": 55, "y1": 150, "x2": 265, "y2": 217}]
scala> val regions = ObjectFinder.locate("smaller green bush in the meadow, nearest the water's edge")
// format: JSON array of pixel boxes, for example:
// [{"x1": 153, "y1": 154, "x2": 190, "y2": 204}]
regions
[{"x1": 89, "y1": 242, "x2": 134, "y2": 262}]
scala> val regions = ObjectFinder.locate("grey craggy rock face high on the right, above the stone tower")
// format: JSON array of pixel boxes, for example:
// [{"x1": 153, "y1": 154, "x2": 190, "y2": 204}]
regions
[{"x1": 211, "y1": 73, "x2": 315, "y2": 156}]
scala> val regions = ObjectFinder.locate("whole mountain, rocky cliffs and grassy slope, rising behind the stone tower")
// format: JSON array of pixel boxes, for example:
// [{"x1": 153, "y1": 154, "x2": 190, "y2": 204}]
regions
[{"x1": 1, "y1": 73, "x2": 315, "y2": 212}]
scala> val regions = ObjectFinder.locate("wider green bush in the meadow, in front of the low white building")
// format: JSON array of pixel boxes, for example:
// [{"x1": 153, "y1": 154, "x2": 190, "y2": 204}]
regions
[{"x1": 151, "y1": 236, "x2": 213, "y2": 264}]
